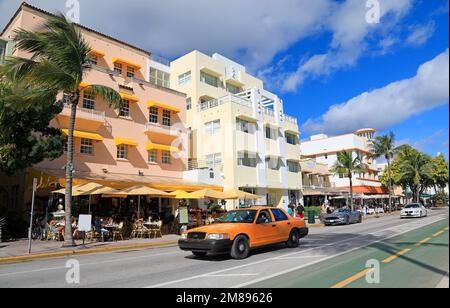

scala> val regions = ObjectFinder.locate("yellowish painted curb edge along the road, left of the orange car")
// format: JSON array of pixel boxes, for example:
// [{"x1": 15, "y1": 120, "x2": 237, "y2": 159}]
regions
[{"x1": 0, "y1": 242, "x2": 178, "y2": 264}]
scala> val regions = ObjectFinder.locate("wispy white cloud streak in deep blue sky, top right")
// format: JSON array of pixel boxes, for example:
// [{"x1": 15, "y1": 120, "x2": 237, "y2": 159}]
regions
[{"x1": 282, "y1": 0, "x2": 411, "y2": 91}]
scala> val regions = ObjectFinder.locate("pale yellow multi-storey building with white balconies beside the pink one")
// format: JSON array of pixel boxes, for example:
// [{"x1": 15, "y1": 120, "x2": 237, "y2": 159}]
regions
[{"x1": 170, "y1": 51, "x2": 302, "y2": 208}]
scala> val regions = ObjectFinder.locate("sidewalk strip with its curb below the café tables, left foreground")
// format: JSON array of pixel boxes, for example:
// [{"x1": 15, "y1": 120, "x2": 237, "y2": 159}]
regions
[{"x1": 0, "y1": 235, "x2": 179, "y2": 264}]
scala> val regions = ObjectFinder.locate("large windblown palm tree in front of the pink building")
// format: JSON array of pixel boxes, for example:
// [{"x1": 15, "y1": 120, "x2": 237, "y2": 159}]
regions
[{"x1": 0, "y1": 13, "x2": 122, "y2": 246}]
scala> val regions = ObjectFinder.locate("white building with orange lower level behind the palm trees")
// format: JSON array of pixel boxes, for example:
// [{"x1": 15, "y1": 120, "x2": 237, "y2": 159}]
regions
[{"x1": 300, "y1": 128, "x2": 386, "y2": 194}]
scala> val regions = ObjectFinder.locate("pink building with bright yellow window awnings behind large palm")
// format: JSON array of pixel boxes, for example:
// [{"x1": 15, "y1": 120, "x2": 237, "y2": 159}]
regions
[{"x1": 0, "y1": 3, "x2": 218, "y2": 219}]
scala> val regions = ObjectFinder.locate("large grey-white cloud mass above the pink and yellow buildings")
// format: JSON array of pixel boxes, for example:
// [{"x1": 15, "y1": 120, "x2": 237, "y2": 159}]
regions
[{"x1": 0, "y1": 0, "x2": 332, "y2": 70}]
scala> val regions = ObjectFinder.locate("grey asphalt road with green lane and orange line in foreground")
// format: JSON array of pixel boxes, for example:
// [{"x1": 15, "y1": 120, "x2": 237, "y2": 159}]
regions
[{"x1": 0, "y1": 210, "x2": 449, "y2": 288}]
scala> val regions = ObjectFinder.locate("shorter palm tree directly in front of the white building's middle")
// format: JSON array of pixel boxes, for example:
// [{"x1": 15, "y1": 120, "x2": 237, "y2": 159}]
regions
[{"x1": 332, "y1": 151, "x2": 367, "y2": 210}]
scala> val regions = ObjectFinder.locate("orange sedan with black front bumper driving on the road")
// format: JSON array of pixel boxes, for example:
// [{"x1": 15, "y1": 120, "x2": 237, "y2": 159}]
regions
[{"x1": 178, "y1": 207, "x2": 308, "y2": 259}]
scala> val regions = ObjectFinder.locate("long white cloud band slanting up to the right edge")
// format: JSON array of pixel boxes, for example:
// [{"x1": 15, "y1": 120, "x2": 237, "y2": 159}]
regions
[{"x1": 303, "y1": 49, "x2": 449, "y2": 134}]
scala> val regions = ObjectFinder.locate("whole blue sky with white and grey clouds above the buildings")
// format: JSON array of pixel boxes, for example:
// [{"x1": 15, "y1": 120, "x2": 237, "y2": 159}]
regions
[{"x1": 0, "y1": 0, "x2": 449, "y2": 157}]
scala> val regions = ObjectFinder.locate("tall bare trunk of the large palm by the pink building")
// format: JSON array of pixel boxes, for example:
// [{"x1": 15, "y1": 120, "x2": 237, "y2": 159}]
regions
[{"x1": 64, "y1": 92, "x2": 80, "y2": 247}]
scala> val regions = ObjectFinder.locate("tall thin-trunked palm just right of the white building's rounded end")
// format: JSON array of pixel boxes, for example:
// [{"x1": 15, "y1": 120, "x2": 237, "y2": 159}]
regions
[{"x1": 367, "y1": 132, "x2": 396, "y2": 212}]
